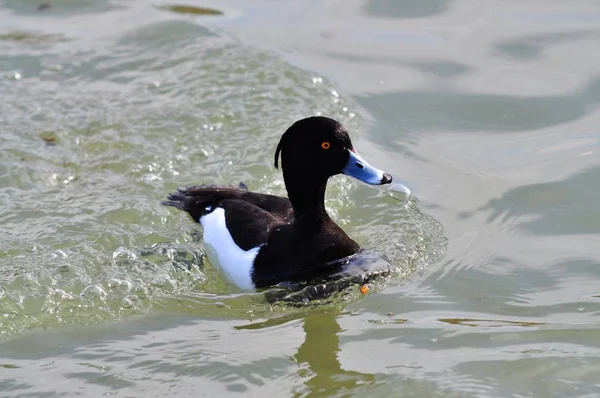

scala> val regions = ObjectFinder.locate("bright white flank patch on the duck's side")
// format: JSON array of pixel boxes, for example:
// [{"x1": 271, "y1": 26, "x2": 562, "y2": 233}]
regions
[{"x1": 200, "y1": 207, "x2": 260, "y2": 290}]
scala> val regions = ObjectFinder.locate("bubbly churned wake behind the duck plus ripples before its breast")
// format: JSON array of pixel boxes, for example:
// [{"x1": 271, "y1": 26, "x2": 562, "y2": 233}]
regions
[{"x1": 0, "y1": 7, "x2": 443, "y2": 335}]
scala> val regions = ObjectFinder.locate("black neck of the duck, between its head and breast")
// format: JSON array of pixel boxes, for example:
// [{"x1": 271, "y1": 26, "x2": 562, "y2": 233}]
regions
[{"x1": 284, "y1": 176, "x2": 329, "y2": 225}]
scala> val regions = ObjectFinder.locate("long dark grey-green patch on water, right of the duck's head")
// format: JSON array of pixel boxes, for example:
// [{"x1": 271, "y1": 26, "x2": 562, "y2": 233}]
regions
[{"x1": 358, "y1": 78, "x2": 598, "y2": 135}]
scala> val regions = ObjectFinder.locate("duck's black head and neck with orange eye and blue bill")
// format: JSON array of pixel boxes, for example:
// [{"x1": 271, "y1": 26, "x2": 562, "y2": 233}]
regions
[{"x1": 275, "y1": 116, "x2": 392, "y2": 215}]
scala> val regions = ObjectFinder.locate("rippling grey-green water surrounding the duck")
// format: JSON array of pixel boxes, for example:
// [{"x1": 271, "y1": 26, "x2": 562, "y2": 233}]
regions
[{"x1": 0, "y1": 0, "x2": 600, "y2": 397}]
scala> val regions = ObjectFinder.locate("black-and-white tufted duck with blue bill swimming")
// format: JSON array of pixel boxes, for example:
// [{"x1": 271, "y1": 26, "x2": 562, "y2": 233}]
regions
[{"x1": 162, "y1": 116, "x2": 406, "y2": 290}]
